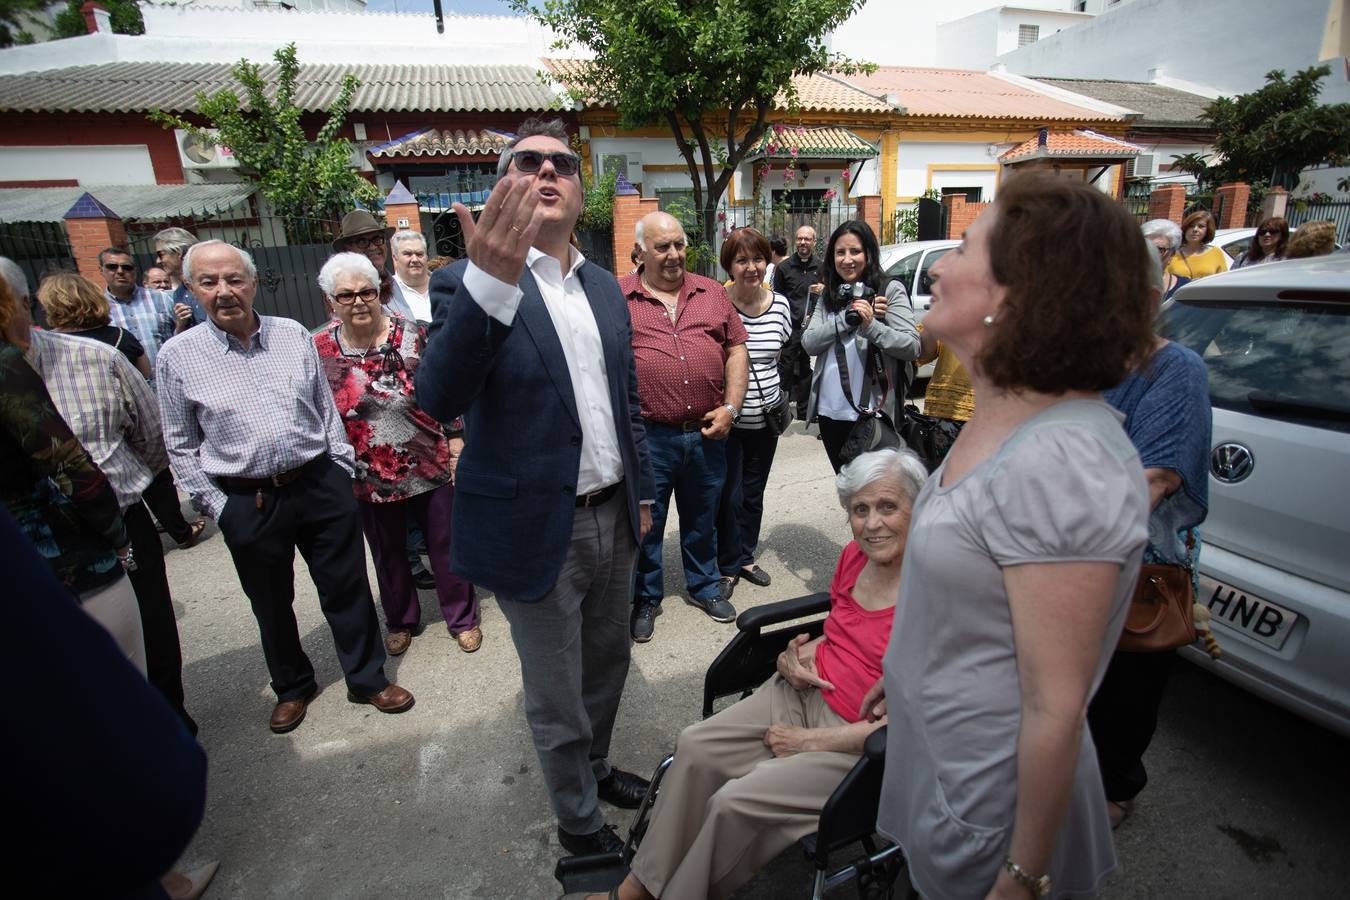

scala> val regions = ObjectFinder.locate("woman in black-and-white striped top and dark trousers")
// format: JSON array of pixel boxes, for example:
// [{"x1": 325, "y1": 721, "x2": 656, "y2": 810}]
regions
[{"x1": 717, "y1": 228, "x2": 792, "y2": 598}]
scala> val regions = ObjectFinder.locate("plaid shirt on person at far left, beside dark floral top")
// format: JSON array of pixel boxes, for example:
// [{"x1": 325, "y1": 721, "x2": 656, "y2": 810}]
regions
[{"x1": 24, "y1": 329, "x2": 169, "y2": 509}]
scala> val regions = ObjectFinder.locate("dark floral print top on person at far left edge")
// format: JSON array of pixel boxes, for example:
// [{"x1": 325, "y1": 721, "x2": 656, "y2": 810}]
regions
[{"x1": 0, "y1": 341, "x2": 127, "y2": 595}]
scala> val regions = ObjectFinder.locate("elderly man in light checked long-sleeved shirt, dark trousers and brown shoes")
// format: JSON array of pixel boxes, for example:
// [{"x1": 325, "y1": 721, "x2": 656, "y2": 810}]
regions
[{"x1": 155, "y1": 240, "x2": 413, "y2": 734}]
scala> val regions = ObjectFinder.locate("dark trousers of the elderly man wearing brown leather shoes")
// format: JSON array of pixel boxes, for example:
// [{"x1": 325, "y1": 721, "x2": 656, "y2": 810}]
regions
[{"x1": 217, "y1": 457, "x2": 389, "y2": 700}]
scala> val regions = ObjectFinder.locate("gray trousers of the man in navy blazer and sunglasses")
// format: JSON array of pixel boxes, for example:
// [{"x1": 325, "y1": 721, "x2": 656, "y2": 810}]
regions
[{"x1": 497, "y1": 490, "x2": 637, "y2": 834}]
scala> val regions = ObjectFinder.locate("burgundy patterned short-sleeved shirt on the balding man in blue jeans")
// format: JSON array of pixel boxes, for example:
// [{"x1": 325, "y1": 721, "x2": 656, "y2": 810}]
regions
[{"x1": 618, "y1": 273, "x2": 748, "y2": 425}]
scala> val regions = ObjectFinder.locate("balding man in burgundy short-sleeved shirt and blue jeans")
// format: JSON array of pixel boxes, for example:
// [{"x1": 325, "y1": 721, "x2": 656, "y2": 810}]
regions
[{"x1": 618, "y1": 212, "x2": 749, "y2": 642}]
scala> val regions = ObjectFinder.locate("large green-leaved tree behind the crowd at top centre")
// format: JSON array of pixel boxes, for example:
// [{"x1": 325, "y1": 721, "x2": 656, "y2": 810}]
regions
[{"x1": 510, "y1": 0, "x2": 872, "y2": 243}]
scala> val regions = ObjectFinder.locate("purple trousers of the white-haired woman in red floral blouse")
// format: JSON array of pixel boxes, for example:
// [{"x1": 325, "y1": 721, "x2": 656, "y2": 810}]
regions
[{"x1": 356, "y1": 484, "x2": 478, "y2": 634}]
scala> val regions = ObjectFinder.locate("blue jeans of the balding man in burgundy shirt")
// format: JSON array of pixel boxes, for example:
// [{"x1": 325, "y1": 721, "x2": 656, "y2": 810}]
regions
[{"x1": 633, "y1": 421, "x2": 726, "y2": 606}]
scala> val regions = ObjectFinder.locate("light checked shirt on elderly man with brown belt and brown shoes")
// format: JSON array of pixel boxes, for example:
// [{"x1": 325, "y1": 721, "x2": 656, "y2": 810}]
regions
[{"x1": 155, "y1": 316, "x2": 356, "y2": 518}]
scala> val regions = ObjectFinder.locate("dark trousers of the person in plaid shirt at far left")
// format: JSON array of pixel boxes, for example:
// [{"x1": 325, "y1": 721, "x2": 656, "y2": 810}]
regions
[{"x1": 122, "y1": 503, "x2": 197, "y2": 735}]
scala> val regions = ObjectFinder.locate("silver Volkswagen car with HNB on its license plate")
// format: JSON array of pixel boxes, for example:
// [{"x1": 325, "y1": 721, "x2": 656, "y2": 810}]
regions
[{"x1": 1158, "y1": 254, "x2": 1350, "y2": 735}]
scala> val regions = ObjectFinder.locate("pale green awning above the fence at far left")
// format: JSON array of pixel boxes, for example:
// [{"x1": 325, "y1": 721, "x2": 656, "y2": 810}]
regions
[{"x1": 0, "y1": 184, "x2": 258, "y2": 221}]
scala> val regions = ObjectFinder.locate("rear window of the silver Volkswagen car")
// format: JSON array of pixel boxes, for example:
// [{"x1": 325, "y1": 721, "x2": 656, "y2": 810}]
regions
[{"x1": 1158, "y1": 293, "x2": 1350, "y2": 432}]
